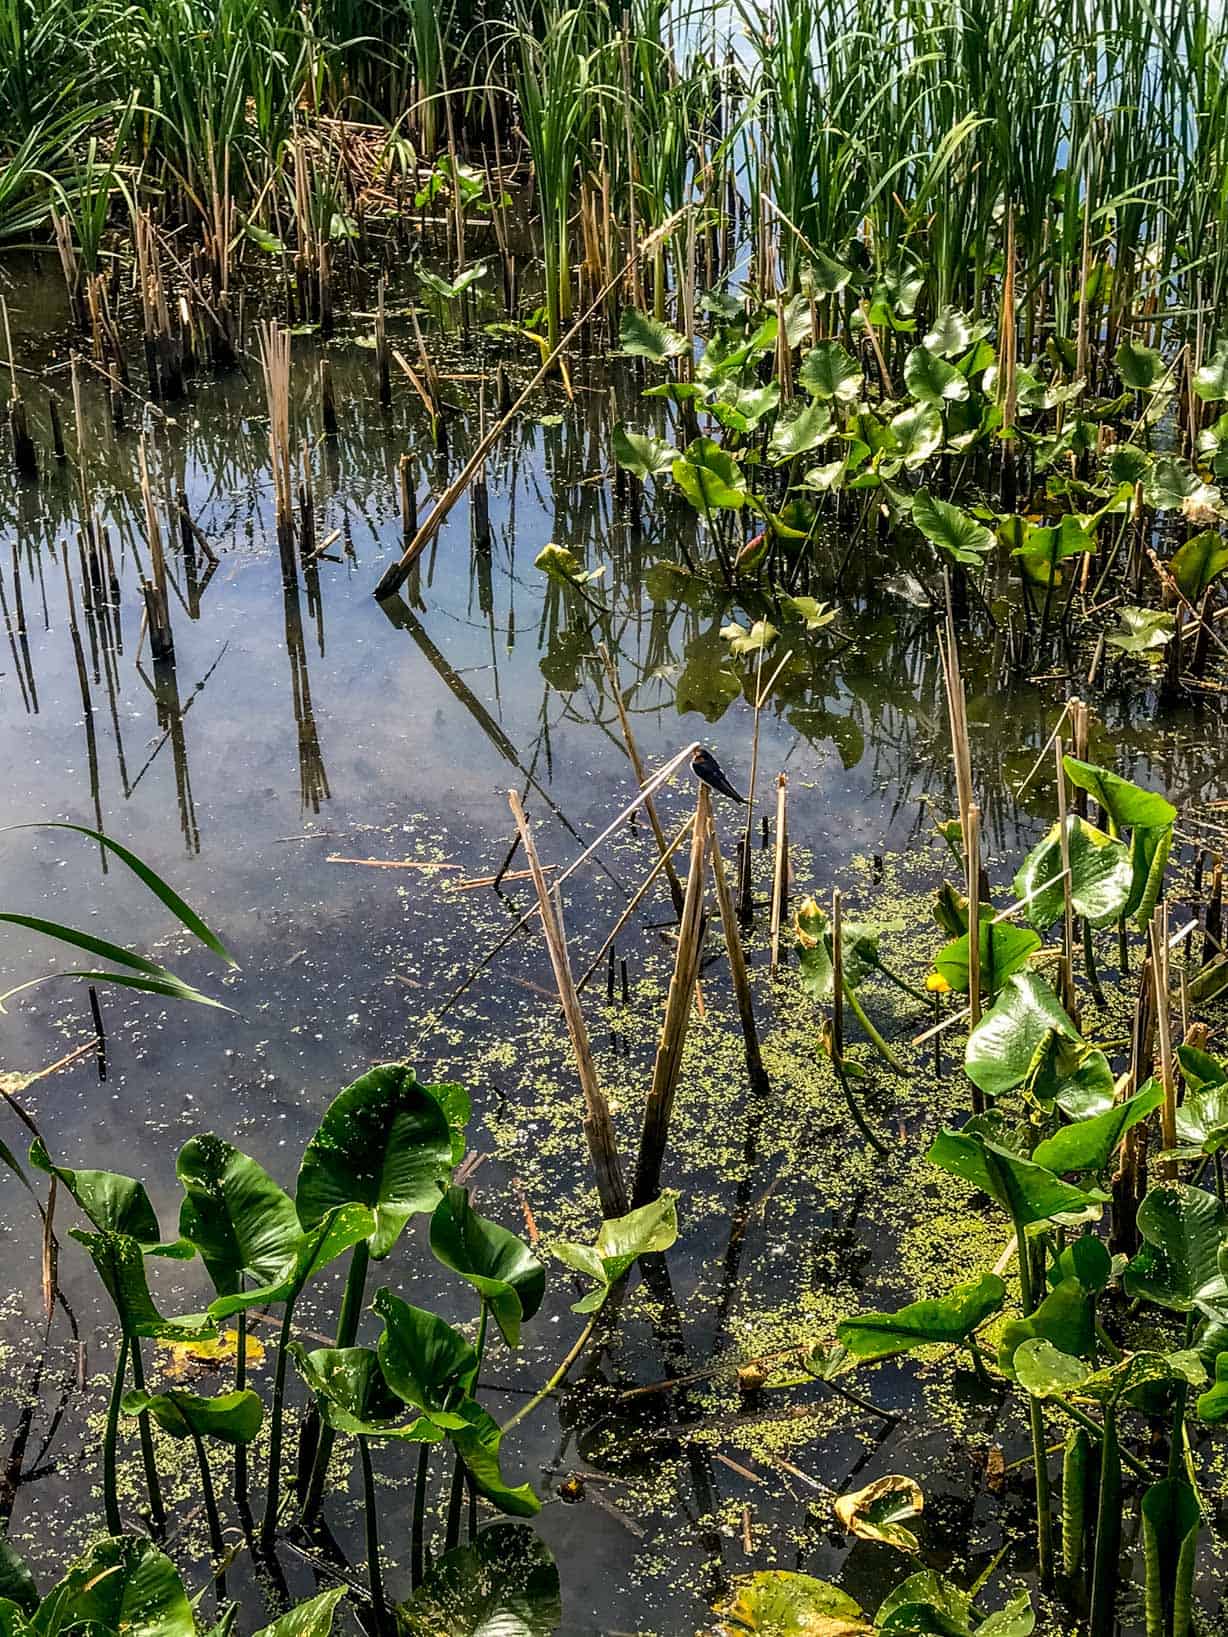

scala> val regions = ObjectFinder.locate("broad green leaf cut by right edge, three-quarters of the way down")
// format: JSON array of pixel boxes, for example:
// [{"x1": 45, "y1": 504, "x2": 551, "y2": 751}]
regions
[{"x1": 1122, "y1": 1182, "x2": 1228, "y2": 1316}]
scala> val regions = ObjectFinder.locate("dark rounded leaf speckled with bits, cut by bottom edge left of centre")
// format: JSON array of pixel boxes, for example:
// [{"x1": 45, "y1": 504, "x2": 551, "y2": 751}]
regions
[{"x1": 396, "y1": 1522, "x2": 563, "y2": 1637}]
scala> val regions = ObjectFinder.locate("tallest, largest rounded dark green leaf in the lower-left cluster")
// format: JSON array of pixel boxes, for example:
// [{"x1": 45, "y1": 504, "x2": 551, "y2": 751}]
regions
[{"x1": 295, "y1": 1062, "x2": 452, "y2": 1260}]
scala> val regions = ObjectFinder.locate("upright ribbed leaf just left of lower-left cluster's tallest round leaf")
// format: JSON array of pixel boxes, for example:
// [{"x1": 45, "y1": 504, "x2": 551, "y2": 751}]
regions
[{"x1": 175, "y1": 1134, "x2": 303, "y2": 1297}]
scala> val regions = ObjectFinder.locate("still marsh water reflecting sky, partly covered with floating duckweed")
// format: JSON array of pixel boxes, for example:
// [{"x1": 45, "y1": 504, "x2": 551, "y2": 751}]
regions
[{"x1": 0, "y1": 264, "x2": 1228, "y2": 1634}]
